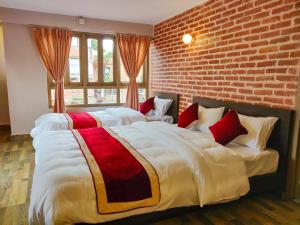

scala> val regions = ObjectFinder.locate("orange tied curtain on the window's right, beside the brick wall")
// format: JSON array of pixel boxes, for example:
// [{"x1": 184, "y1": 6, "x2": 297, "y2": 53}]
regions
[{"x1": 117, "y1": 34, "x2": 151, "y2": 110}]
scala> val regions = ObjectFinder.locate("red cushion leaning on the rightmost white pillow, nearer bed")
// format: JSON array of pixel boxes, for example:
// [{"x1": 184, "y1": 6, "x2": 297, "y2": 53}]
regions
[{"x1": 209, "y1": 110, "x2": 248, "y2": 145}]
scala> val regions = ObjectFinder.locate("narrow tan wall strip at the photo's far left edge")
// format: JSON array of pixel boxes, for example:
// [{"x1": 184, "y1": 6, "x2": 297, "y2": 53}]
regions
[{"x1": 0, "y1": 24, "x2": 9, "y2": 125}]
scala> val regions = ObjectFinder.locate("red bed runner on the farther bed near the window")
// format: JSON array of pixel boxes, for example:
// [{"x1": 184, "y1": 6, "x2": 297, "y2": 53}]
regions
[{"x1": 64, "y1": 112, "x2": 102, "y2": 130}]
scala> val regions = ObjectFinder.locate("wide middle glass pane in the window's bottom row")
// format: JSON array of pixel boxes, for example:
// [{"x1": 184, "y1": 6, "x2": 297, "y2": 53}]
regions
[{"x1": 88, "y1": 89, "x2": 117, "y2": 104}]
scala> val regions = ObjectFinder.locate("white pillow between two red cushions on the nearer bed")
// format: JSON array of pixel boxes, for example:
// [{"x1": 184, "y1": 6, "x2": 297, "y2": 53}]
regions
[{"x1": 194, "y1": 105, "x2": 225, "y2": 133}]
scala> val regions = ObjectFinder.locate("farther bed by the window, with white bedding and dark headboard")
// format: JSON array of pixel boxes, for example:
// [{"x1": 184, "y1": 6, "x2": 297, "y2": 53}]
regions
[{"x1": 30, "y1": 92, "x2": 178, "y2": 138}]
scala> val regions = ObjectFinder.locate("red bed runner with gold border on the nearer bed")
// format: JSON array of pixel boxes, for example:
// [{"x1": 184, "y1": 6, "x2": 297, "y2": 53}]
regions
[{"x1": 72, "y1": 128, "x2": 160, "y2": 214}]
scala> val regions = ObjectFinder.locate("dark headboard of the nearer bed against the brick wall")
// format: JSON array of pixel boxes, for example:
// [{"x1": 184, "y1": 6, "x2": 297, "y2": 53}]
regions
[{"x1": 193, "y1": 96, "x2": 293, "y2": 173}]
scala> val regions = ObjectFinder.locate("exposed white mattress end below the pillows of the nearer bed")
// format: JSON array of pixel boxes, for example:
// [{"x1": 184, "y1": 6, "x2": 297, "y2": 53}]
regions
[{"x1": 226, "y1": 143, "x2": 279, "y2": 177}]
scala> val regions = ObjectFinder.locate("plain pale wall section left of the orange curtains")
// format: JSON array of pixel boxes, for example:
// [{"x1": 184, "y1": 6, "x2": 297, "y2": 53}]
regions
[{"x1": 3, "y1": 24, "x2": 49, "y2": 135}]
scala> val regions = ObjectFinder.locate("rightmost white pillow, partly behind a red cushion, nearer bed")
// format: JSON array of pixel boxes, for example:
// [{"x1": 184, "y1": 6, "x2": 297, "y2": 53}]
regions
[{"x1": 232, "y1": 114, "x2": 278, "y2": 151}]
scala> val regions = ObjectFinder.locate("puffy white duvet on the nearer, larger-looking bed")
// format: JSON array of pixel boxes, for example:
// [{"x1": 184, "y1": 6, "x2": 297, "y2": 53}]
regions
[{"x1": 29, "y1": 122, "x2": 249, "y2": 225}]
